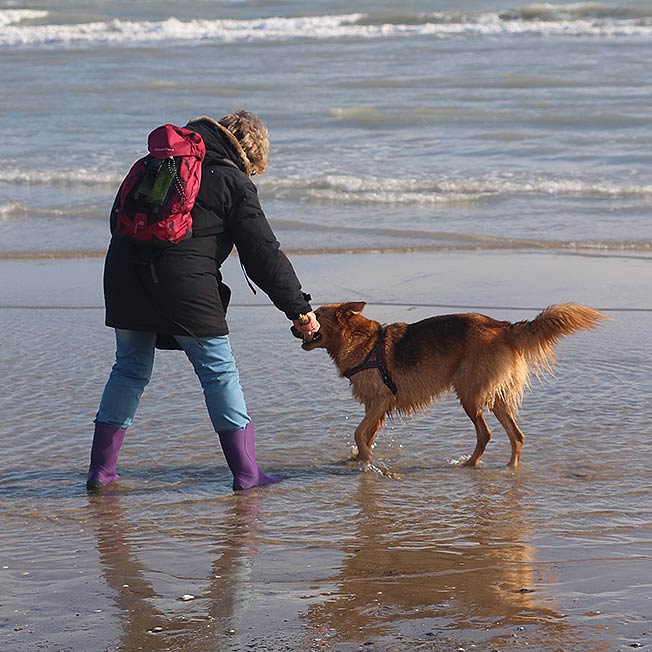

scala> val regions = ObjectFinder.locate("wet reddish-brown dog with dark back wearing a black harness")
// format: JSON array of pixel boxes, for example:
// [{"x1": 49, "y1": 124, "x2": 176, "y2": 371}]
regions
[{"x1": 293, "y1": 301, "x2": 606, "y2": 466}]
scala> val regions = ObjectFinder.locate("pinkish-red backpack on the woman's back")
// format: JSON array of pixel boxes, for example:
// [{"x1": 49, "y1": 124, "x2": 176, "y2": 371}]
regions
[{"x1": 114, "y1": 124, "x2": 206, "y2": 247}]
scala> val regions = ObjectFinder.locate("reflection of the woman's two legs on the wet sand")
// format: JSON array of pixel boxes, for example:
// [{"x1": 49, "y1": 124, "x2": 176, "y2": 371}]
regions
[{"x1": 89, "y1": 492, "x2": 258, "y2": 652}]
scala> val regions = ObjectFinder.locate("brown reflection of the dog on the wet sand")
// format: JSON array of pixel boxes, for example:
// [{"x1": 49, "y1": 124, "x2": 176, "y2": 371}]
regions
[{"x1": 308, "y1": 473, "x2": 608, "y2": 650}]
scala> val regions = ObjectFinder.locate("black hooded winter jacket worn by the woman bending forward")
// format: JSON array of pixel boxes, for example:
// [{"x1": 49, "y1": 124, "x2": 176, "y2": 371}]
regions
[{"x1": 104, "y1": 118, "x2": 311, "y2": 348}]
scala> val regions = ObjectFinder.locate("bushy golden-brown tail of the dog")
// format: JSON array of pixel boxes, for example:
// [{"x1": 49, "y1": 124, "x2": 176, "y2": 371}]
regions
[{"x1": 511, "y1": 303, "x2": 608, "y2": 376}]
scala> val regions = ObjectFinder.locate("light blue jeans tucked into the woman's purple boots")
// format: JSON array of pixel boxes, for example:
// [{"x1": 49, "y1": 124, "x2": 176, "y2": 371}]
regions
[{"x1": 95, "y1": 329, "x2": 250, "y2": 432}]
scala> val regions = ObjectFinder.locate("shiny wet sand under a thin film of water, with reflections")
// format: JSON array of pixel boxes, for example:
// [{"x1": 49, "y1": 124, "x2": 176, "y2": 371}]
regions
[{"x1": 0, "y1": 251, "x2": 652, "y2": 652}]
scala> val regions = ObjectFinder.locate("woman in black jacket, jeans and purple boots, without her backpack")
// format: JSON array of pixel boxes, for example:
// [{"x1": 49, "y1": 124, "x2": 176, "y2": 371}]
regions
[{"x1": 86, "y1": 111, "x2": 319, "y2": 491}]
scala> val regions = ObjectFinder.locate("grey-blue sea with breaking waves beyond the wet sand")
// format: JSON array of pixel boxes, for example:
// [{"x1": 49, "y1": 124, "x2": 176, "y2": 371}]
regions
[{"x1": 0, "y1": 0, "x2": 652, "y2": 255}]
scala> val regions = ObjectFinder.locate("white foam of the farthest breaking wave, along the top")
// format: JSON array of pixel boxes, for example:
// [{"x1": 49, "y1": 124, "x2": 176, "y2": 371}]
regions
[{"x1": 0, "y1": 8, "x2": 652, "y2": 47}]
